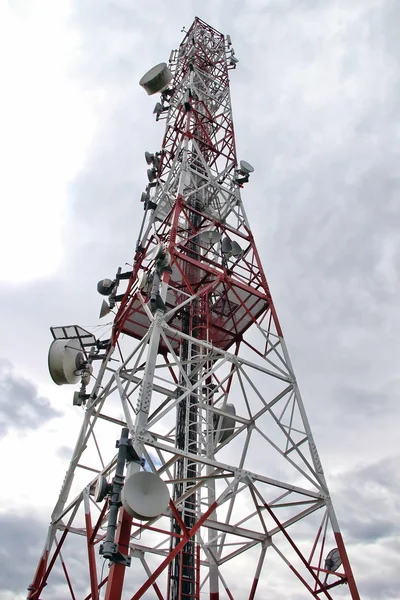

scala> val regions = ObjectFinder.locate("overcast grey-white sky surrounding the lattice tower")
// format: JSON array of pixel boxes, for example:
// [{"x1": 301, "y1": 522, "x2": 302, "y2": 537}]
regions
[{"x1": 0, "y1": 0, "x2": 400, "y2": 600}]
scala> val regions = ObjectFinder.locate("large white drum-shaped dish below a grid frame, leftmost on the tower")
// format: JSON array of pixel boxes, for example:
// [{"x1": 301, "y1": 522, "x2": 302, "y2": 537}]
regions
[{"x1": 48, "y1": 339, "x2": 85, "y2": 385}]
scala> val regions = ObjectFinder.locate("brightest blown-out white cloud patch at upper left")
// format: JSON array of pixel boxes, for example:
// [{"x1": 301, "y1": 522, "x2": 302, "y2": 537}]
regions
[{"x1": 0, "y1": 2, "x2": 95, "y2": 283}]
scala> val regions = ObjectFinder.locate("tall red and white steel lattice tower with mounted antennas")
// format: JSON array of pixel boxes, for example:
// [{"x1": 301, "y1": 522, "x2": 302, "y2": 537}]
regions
[{"x1": 28, "y1": 18, "x2": 359, "y2": 600}]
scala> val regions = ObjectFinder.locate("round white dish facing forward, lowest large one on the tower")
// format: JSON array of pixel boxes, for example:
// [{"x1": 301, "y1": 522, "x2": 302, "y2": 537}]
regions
[{"x1": 121, "y1": 471, "x2": 169, "y2": 521}]
